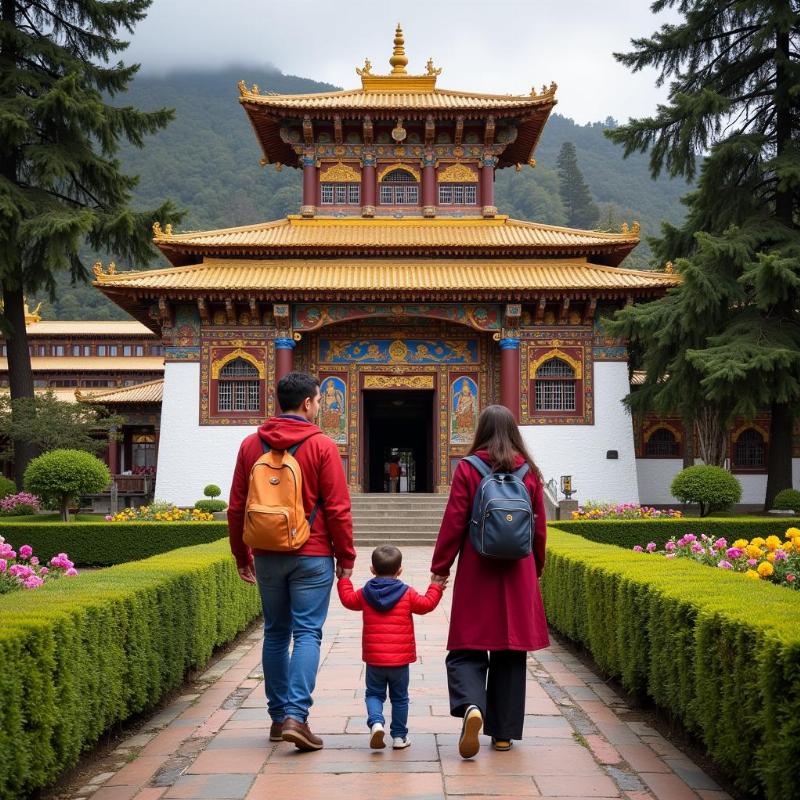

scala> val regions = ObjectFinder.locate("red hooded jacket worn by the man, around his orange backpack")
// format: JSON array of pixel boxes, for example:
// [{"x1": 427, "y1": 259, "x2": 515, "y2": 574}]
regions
[{"x1": 228, "y1": 416, "x2": 356, "y2": 569}]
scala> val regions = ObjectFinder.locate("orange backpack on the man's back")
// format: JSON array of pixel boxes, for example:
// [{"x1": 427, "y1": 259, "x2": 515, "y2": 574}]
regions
[{"x1": 244, "y1": 434, "x2": 319, "y2": 553}]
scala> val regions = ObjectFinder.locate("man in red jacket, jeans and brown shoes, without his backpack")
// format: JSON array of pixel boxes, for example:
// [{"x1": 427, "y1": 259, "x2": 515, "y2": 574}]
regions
[{"x1": 228, "y1": 372, "x2": 356, "y2": 750}]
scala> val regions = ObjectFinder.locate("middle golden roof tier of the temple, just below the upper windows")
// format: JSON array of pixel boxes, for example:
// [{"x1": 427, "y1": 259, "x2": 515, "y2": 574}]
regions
[{"x1": 154, "y1": 215, "x2": 639, "y2": 266}]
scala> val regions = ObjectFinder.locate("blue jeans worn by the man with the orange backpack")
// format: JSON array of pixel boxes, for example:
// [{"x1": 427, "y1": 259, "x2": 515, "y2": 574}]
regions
[{"x1": 254, "y1": 553, "x2": 333, "y2": 722}]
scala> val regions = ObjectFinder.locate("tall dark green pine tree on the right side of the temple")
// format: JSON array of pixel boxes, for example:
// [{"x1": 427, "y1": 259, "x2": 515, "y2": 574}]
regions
[{"x1": 607, "y1": 0, "x2": 800, "y2": 507}]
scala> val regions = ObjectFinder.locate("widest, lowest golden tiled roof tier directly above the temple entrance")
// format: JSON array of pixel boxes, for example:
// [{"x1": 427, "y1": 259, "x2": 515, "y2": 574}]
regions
[{"x1": 95, "y1": 258, "x2": 680, "y2": 299}]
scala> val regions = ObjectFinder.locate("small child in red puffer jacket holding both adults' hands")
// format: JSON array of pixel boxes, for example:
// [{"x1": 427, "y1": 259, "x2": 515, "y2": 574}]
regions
[{"x1": 337, "y1": 544, "x2": 447, "y2": 750}]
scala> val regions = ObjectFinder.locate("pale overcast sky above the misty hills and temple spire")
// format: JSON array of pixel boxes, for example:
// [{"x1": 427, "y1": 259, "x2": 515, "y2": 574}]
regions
[{"x1": 124, "y1": 0, "x2": 675, "y2": 123}]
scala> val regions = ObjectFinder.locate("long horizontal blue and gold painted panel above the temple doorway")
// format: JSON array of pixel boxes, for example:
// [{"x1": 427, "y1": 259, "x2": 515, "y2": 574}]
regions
[{"x1": 319, "y1": 338, "x2": 478, "y2": 364}]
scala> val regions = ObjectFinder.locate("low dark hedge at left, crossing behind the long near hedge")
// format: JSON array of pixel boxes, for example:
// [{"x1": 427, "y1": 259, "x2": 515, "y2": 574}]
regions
[{"x1": 0, "y1": 522, "x2": 228, "y2": 567}]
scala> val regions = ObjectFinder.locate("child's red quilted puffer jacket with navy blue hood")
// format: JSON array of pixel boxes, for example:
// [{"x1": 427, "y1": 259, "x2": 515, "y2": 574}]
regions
[{"x1": 336, "y1": 578, "x2": 442, "y2": 667}]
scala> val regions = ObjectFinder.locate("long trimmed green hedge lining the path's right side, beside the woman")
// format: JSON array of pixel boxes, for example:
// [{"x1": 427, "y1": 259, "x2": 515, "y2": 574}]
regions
[{"x1": 542, "y1": 523, "x2": 800, "y2": 800}]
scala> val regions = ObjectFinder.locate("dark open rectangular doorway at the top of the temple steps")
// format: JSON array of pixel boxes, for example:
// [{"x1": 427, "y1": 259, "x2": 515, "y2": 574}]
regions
[{"x1": 362, "y1": 390, "x2": 434, "y2": 493}]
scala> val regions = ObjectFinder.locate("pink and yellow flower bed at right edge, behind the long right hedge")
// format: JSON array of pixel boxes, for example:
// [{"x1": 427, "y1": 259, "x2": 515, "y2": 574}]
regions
[{"x1": 633, "y1": 528, "x2": 800, "y2": 589}]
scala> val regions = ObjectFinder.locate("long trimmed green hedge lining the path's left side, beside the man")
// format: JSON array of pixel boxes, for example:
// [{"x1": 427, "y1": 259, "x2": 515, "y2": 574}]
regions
[{"x1": 0, "y1": 542, "x2": 261, "y2": 800}]
